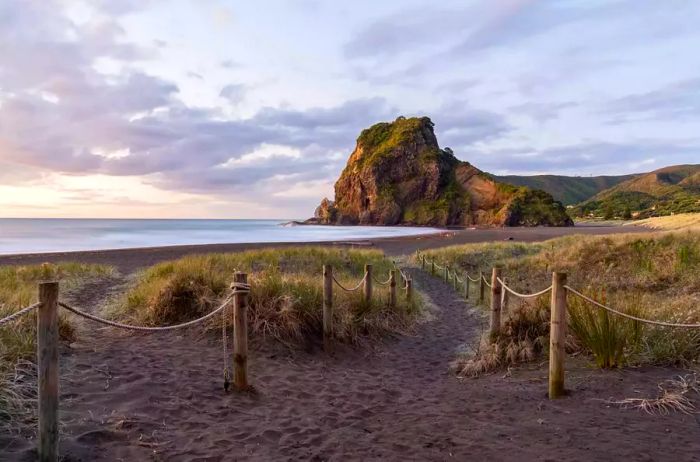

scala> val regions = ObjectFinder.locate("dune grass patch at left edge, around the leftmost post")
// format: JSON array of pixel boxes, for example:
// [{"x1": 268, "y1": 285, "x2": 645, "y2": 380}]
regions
[{"x1": 0, "y1": 263, "x2": 113, "y2": 433}]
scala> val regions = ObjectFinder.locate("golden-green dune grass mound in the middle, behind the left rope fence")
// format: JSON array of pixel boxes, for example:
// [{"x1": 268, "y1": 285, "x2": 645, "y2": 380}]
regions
[{"x1": 111, "y1": 247, "x2": 419, "y2": 345}]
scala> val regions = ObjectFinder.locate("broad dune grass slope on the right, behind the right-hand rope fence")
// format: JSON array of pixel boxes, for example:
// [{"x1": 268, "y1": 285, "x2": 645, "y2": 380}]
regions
[{"x1": 425, "y1": 232, "x2": 700, "y2": 375}]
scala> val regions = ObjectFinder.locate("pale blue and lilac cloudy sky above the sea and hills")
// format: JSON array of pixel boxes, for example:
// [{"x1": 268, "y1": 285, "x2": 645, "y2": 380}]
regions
[{"x1": 0, "y1": 0, "x2": 700, "y2": 218}]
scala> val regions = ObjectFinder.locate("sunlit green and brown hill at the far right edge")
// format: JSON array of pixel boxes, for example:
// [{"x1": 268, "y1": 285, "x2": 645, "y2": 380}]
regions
[{"x1": 572, "y1": 165, "x2": 700, "y2": 218}]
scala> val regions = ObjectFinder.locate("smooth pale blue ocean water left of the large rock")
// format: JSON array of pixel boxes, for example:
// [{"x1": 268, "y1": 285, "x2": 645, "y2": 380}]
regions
[{"x1": 0, "y1": 218, "x2": 439, "y2": 255}]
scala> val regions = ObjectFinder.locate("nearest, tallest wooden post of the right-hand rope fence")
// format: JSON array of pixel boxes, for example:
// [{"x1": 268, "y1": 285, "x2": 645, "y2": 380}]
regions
[{"x1": 549, "y1": 273, "x2": 567, "y2": 399}]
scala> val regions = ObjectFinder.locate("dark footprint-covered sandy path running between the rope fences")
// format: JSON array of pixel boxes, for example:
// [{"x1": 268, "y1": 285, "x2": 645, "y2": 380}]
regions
[{"x1": 5, "y1": 262, "x2": 700, "y2": 461}]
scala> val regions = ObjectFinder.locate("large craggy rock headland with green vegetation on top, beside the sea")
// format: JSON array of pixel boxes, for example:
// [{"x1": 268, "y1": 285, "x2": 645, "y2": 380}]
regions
[{"x1": 313, "y1": 117, "x2": 573, "y2": 226}]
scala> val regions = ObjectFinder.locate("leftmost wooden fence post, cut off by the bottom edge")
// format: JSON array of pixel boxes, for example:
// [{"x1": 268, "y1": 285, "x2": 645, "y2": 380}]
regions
[{"x1": 36, "y1": 282, "x2": 58, "y2": 462}]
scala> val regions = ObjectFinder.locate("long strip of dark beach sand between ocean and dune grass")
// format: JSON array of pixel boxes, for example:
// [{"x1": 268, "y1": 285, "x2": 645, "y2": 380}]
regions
[{"x1": 0, "y1": 226, "x2": 653, "y2": 274}]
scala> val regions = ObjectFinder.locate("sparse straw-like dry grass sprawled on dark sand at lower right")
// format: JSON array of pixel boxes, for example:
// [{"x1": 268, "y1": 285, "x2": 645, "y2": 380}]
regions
[{"x1": 607, "y1": 374, "x2": 700, "y2": 415}]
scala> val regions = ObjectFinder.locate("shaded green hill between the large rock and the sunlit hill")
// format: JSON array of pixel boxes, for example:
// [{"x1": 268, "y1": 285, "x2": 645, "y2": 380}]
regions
[{"x1": 494, "y1": 175, "x2": 637, "y2": 205}]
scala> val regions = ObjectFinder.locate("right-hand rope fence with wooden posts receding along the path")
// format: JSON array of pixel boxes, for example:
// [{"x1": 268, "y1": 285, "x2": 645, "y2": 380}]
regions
[{"x1": 418, "y1": 249, "x2": 700, "y2": 399}]
